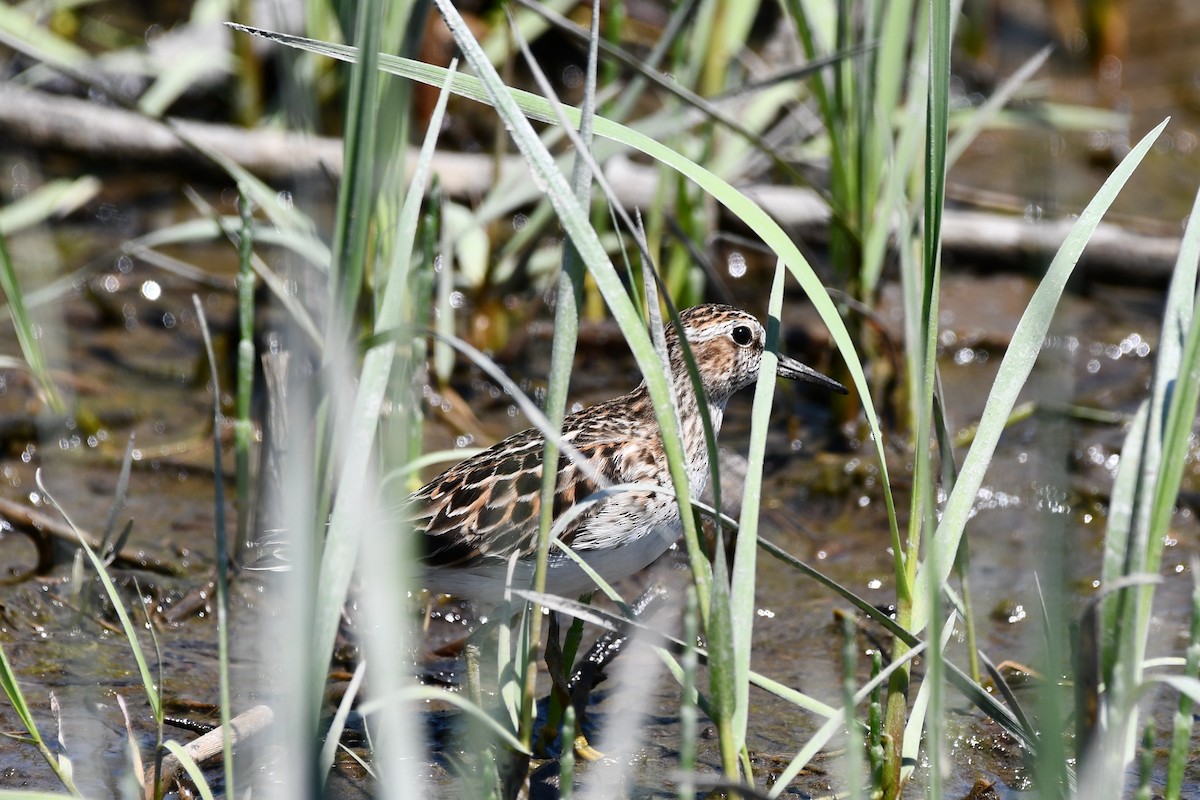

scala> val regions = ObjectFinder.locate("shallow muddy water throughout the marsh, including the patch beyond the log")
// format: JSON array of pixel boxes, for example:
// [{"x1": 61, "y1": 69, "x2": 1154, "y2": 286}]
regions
[{"x1": 0, "y1": 0, "x2": 1200, "y2": 798}]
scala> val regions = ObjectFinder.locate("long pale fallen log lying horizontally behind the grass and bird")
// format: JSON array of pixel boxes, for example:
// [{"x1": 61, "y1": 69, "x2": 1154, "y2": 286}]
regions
[{"x1": 0, "y1": 84, "x2": 1180, "y2": 284}]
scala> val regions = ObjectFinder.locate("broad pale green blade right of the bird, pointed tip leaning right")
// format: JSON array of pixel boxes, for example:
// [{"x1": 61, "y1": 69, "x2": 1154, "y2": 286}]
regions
[{"x1": 911, "y1": 120, "x2": 1166, "y2": 632}]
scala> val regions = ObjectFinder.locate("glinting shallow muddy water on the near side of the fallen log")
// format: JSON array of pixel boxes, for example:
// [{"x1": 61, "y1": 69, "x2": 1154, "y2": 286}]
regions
[{"x1": 0, "y1": 231, "x2": 1200, "y2": 796}]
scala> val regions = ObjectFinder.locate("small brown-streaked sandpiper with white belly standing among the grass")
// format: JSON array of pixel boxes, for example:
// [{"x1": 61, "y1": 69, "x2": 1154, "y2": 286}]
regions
[{"x1": 407, "y1": 303, "x2": 846, "y2": 602}]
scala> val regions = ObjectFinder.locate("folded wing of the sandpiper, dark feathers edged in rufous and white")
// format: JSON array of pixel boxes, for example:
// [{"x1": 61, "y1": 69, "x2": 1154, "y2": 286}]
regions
[{"x1": 407, "y1": 429, "x2": 624, "y2": 567}]
